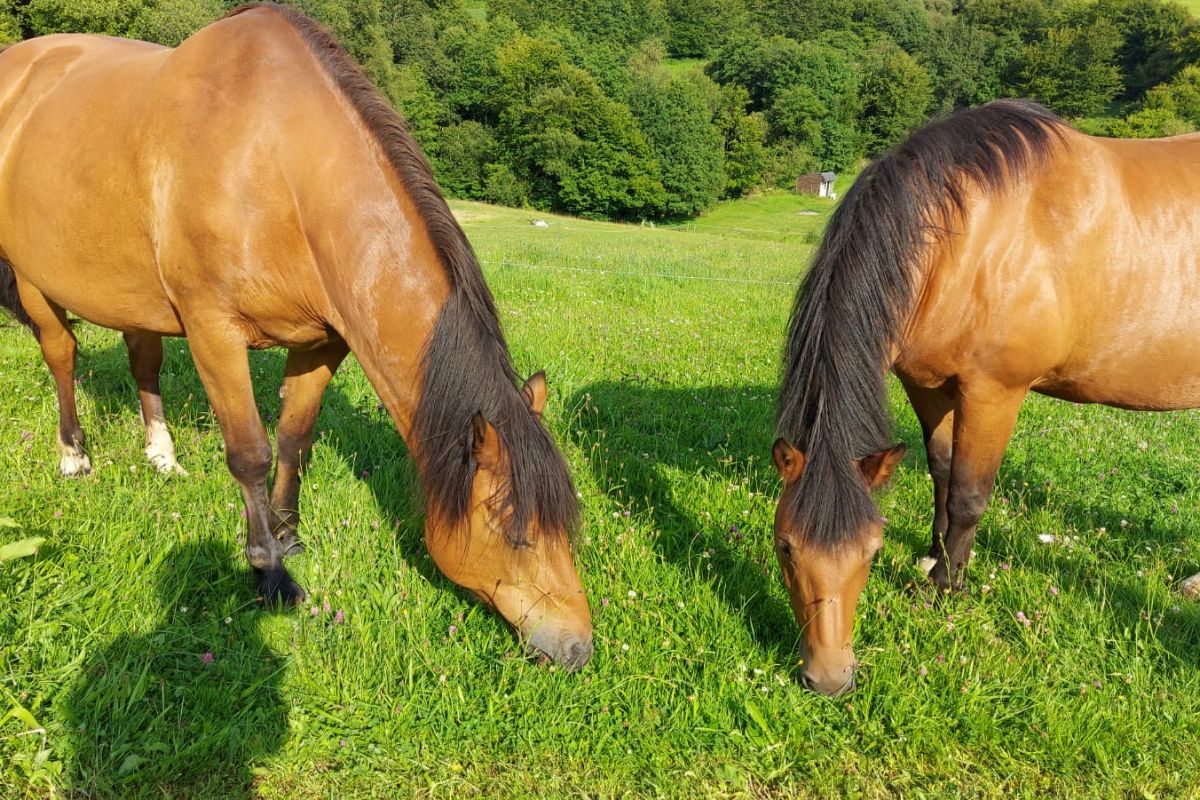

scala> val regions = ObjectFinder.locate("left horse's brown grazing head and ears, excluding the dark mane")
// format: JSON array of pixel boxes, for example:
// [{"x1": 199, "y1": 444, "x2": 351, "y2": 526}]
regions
[{"x1": 425, "y1": 373, "x2": 592, "y2": 669}]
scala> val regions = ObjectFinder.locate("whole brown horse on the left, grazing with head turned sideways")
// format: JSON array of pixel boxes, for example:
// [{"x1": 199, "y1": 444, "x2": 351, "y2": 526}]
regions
[{"x1": 0, "y1": 4, "x2": 592, "y2": 667}]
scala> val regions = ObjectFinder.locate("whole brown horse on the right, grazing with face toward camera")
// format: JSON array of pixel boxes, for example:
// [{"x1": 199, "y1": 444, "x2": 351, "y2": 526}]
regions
[{"x1": 774, "y1": 101, "x2": 1200, "y2": 694}]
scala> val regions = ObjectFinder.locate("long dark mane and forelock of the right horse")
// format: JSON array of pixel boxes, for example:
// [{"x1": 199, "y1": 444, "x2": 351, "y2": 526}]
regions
[{"x1": 776, "y1": 101, "x2": 1064, "y2": 547}]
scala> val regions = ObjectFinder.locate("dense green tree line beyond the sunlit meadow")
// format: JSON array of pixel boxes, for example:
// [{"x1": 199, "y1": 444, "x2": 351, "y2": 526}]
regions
[{"x1": 0, "y1": 0, "x2": 1200, "y2": 218}]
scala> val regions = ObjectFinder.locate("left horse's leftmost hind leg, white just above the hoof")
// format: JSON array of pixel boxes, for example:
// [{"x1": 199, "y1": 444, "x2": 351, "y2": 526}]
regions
[{"x1": 17, "y1": 279, "x2": 91, "y2": 477}]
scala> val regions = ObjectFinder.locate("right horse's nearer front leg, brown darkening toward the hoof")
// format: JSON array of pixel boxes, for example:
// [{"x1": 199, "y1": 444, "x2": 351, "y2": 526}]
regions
[{"x1": 929, "y1": 385, "x2": 1026, "y2": 590}]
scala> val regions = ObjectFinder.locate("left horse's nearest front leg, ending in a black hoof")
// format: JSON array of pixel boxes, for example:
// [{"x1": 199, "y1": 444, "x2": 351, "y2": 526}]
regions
[{"x1": 187, "y1": 318, "x2": 305, "y2": 604}]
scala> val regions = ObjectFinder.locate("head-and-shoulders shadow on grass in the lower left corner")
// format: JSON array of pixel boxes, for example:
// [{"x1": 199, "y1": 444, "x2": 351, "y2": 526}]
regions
[{"x1": 66, "y1": 540, "x2": 287, "y2": 799}]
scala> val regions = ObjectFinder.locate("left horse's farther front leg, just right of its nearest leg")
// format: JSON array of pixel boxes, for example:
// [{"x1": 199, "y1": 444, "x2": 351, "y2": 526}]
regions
[{"x1": 271, "y1": 339, "x2": 349, "y2": 555}]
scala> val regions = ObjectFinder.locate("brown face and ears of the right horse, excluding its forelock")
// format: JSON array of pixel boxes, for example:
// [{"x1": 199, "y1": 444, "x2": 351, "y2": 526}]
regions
[{"x1": 772, "y1": 438, "x2": 905, "y2": 696}]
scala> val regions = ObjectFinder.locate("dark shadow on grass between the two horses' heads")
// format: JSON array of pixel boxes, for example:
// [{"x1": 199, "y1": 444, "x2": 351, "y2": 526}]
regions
[{"x1": 566, "y1": 375, "x2": 799, "y2": 655}]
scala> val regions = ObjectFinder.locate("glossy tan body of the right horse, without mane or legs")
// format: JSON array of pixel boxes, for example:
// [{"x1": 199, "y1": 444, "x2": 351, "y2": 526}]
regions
[{"x1": 898, "y1": 128, "x2": 1200, "y2": 409}]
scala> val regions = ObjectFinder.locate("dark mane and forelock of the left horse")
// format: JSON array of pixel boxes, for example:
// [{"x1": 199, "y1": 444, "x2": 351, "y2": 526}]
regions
[{"x1": 229, "y1": 2, "x2": 578, "y2": 546}]
